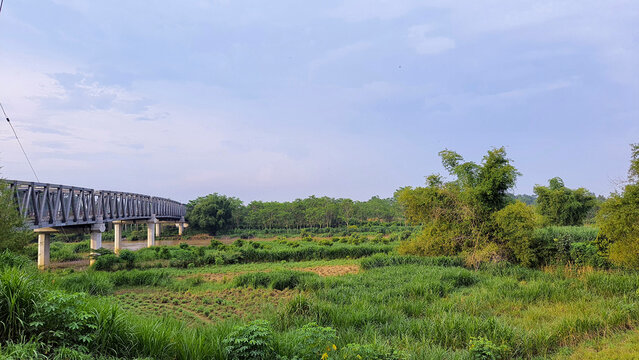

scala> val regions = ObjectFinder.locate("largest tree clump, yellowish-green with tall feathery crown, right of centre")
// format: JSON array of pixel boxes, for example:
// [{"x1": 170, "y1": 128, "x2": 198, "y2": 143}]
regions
[{"x1": 397, "y1": 147, "x2": 519, "y2": 262}]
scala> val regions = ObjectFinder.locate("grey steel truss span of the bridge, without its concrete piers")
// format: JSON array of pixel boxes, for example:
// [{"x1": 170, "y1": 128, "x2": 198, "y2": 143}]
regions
[{"x1": 8, "y1": 180, "x2": 186, "y2": 229}]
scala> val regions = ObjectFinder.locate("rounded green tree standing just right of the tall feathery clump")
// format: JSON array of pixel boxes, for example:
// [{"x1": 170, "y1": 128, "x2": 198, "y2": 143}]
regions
[{"x1": 534, "y1": 177, "x2": 597, "y2": 226}]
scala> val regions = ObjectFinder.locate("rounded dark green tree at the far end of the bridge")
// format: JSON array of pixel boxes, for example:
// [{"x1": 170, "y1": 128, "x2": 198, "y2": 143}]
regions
[{"x1": 186, "y1": 193, "x2": 241, "y2": 234}]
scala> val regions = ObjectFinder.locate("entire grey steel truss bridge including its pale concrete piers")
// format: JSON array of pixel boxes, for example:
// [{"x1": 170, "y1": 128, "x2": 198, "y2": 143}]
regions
[{"x1": 6, "y1": 180, "x2": 187, "y2": 268}]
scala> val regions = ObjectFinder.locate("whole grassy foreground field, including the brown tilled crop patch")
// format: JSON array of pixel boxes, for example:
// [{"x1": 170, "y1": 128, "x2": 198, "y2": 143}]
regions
[{"x1": 0, "y1": 229, "x2": 639, "y2": 360}]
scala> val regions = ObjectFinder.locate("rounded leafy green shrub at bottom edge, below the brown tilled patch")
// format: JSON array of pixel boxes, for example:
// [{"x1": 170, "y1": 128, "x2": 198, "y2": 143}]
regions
[{"x1": 223, "y1": 320, "x2": 275, "y2": 360}]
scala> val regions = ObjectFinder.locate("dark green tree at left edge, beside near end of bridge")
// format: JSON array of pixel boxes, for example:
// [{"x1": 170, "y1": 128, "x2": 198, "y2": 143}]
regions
[{"x1": 0, "y1": 180, "x2": 31, "y2": 251}]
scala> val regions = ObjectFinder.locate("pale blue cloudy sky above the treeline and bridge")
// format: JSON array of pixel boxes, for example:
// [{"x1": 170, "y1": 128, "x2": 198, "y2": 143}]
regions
[{"x1": 0, "y1": 0, "x2": 639, "y2": 201}]
